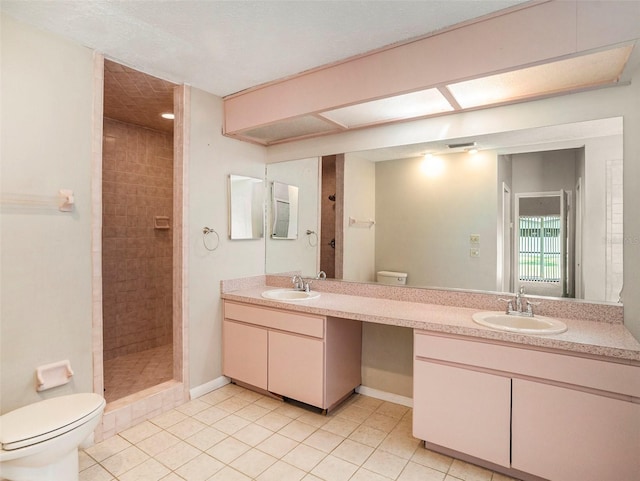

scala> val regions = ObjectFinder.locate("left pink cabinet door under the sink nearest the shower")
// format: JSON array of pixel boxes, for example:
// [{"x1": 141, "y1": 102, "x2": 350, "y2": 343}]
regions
[{"x1": 222, "y1": 319, "x2": 267, "y2": 389}]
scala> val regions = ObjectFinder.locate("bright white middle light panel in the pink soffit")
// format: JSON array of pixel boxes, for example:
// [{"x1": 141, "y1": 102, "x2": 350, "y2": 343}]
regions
[{"x1": 320, "y1": 88, "x2": 453, "y2": 127}]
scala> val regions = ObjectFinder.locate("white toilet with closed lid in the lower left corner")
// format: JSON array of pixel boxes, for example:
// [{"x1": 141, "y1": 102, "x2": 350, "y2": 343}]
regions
[{"x1": 0, "y1": 393, "x2": 106, "y2": 481}]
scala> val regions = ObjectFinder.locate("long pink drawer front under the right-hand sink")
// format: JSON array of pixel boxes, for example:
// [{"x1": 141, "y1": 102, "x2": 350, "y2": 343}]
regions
[{"x1": 414, "y1": 331, "x2": 640, "y2": 397}]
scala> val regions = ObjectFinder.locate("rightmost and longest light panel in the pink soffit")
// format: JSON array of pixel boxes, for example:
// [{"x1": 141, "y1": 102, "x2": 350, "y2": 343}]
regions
[{"x1": 447, "y1": 45, "x2": 633, "y2": 109}]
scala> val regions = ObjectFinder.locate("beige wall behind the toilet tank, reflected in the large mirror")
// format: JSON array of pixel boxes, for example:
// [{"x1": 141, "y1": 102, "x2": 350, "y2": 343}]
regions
[{"x1": 376, "y1": 151, "x2": 498, "y2": 290}]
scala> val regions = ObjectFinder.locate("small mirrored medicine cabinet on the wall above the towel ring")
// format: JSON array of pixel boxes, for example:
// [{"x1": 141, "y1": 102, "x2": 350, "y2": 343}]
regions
[{"x1": 229, "y1": 174, "x2": 264, "y2": 240}]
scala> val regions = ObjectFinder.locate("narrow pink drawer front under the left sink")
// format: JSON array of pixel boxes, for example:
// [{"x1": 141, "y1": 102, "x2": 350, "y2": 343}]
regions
[{"x1": 224, "y1": 301, "x2": 325, "y2": 339}]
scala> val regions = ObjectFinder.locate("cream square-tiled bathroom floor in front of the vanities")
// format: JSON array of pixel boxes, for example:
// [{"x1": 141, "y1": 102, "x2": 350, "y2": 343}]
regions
[{"x1": 80, "y1": 384, "x2": 512, "y2": 481}]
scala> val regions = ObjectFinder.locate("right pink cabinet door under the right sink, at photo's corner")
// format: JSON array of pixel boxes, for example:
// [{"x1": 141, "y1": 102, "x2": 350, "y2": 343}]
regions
[{"x1": 513, "y1": 379, "x2": 640, "y2": 481}]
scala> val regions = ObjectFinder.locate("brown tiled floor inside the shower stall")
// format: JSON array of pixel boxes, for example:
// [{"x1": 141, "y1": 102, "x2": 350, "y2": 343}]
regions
[{"x1": 104, "y1": 344, "x2": 173, "y2": 402}]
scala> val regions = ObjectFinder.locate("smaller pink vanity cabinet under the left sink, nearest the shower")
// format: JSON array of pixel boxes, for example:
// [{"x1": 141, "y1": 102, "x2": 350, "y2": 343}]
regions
[{"x1": 222, "y1": 301, "x2": 362, "y2": 410}]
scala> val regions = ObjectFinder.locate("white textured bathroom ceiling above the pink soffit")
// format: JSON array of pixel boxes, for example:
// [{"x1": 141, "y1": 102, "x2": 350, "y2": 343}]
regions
[{"x1": 1, "y1": 0, "x2": 524, "y2": 96}]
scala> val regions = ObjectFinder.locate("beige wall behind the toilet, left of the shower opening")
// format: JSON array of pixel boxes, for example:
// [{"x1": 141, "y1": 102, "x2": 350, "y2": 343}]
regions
[{"x1": 0, "y1": 15, "x2": 93, "y2": 412}]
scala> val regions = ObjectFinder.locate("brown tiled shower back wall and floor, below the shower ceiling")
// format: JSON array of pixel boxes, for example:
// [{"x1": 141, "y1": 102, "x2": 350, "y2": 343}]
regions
[{"x1": 102, "y1": 118, "x2": 173, "y2": 402}]
